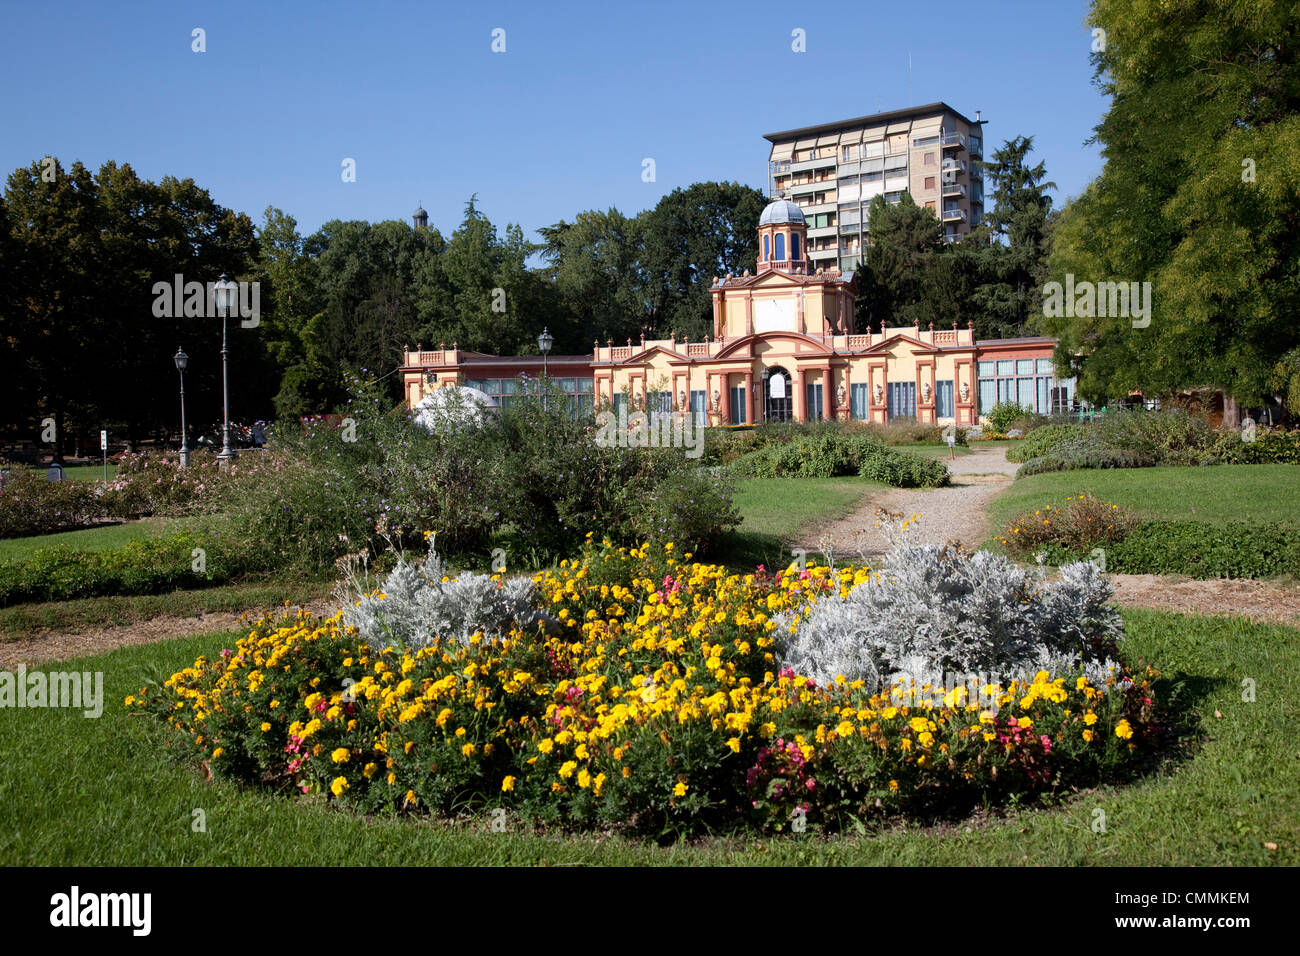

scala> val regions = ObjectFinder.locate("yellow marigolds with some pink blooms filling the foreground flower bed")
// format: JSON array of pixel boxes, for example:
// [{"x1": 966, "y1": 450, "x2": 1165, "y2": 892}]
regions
[{"x1": 134, "y1": 544, "x2": 1153, "y2": 834}]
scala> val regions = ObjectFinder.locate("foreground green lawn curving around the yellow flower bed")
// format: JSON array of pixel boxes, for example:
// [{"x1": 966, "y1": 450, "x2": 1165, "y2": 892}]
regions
[{"x1": 0, "y1": 611, "x2": 1300, "y2": 866}]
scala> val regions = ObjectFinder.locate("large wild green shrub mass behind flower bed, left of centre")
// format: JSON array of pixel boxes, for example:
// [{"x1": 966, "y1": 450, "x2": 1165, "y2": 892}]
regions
[{"x1": 222, "y1": 374, "x2": 740, "y2": 570}]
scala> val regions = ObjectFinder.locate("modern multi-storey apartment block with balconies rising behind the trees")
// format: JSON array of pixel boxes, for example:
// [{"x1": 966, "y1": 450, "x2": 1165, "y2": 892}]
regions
[{"x1": 764, "y1": 103, "x2": 985, "y2": 272}]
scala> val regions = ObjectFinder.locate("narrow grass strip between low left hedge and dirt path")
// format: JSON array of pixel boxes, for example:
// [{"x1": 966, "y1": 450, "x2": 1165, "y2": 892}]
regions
[{"x1": 0, "y1": 580, "x2": 334, "y2": 644}]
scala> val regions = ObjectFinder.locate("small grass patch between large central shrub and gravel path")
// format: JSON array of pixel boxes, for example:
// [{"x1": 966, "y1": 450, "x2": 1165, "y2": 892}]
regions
[{"x1": 709, "y1": 476, "x2": 889, "y2": 571}]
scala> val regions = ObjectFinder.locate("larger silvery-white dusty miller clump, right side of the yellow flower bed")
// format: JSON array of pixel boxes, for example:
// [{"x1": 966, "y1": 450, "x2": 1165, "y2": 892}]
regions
[{"x1": 775, "y1": 540, "x2": 1122, "y2": 691}]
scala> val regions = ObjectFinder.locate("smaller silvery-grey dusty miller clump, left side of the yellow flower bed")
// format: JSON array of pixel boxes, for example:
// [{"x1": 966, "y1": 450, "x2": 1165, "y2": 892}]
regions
[{"x1": 342, "y1": 538, "x2": 554, "y2": 650}]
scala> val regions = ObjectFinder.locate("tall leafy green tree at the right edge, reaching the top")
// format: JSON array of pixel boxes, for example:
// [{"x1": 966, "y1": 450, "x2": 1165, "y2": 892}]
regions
[{"x1": 1041, "y1": 0, "x2": 1300, "y2": 423}]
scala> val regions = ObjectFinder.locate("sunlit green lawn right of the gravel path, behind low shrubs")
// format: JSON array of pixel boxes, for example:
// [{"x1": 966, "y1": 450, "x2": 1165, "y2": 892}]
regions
[{"x1": 989, "y1": 464, "x2": 1300, "y2": 531}]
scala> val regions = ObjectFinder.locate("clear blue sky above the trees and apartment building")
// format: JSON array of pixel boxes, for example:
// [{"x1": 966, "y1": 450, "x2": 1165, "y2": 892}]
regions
[{"x1": 0, "y1": 0, "x2": 1106, "y2": 238}]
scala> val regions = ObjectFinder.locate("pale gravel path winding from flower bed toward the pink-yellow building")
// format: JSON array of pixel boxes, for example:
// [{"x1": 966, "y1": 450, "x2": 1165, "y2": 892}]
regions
[{"x1": 796, "y1": 447, "x2": 1019, "y2": 563}]
